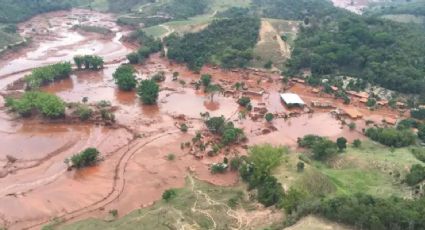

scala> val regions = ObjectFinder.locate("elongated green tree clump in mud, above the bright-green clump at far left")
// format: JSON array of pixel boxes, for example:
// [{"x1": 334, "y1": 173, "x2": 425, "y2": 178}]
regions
[{"x1": 25, "y1": 62, "x2": 72, "y2": 89}]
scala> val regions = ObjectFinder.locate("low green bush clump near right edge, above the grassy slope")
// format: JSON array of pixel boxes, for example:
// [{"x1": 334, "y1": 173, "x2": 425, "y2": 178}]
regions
[{"x1": 366, "y1": 128, "x2": 416, "y2": 148}]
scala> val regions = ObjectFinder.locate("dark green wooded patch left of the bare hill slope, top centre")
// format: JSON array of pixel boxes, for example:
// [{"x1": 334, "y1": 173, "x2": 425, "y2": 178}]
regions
[{"x1": 166, "y1": 18, "x2": 260, "y2": 71}]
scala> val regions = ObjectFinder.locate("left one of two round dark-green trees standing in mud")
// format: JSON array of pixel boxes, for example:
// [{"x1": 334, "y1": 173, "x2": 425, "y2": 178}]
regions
[{"x1": 112, "y1": 64, "x2": 137, "y2": 91}]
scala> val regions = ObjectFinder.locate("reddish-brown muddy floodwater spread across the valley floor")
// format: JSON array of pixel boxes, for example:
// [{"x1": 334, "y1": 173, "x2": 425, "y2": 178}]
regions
[{"x1": 0, "y1": 7, "x2": 404, "y2": 229}]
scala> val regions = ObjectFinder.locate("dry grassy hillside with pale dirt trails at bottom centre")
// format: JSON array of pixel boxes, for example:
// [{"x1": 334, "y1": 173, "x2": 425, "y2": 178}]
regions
[{"x1": 53, "y1": 176, "x2": 282, "y2": 230}]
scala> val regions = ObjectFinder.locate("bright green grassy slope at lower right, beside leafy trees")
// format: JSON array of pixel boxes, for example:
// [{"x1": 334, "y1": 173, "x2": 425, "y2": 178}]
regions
[{"x1": 275, "y1": 141, "x2": 423, "y2": 197}]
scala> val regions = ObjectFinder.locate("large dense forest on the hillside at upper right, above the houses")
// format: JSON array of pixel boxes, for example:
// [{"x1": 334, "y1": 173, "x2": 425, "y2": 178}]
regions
[{"x1": 288, "y1": 14, "x2": 425, "y2": 94}]
